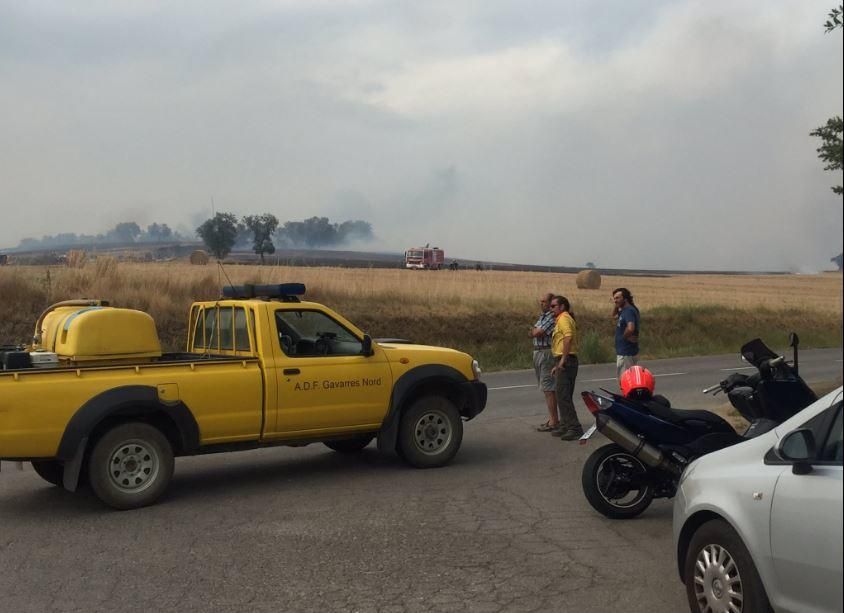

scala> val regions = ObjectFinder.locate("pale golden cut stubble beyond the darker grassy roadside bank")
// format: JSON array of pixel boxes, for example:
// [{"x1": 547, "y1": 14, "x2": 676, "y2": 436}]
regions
[{"x1": 198, "y1": 267, "x2": 842, "y2": 314}]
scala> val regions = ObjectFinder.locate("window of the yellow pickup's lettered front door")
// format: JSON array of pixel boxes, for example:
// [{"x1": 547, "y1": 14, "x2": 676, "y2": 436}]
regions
[{"x1": 275, "y1": 310, "x2": 363, "y2": 358}]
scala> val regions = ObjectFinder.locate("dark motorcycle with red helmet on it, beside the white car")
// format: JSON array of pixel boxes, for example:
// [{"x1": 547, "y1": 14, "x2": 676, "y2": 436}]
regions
[{"x1": 580, "y1": 333, "x2": 817, "y2": 519}]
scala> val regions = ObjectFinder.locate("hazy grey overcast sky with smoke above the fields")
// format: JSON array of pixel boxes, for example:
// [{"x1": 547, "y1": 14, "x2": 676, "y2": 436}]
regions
[{"x1": 0, "y1": 0, "x2": 842, "y2": 271}]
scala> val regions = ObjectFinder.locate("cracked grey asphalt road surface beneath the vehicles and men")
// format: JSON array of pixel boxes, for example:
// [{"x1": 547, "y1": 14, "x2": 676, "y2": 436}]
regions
[{"x1": 0, "y1": 350, "x2": 842, "y2": 613}]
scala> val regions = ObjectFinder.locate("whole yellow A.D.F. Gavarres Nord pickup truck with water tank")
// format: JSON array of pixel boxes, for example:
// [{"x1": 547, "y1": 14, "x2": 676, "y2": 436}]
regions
[{"x1": 0, "y1": 283, "x2": 487, "y2": 509}]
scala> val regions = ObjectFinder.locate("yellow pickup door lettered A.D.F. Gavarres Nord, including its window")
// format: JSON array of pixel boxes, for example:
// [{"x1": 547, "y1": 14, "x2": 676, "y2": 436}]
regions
[{"x1": 267, "y1": 308, "x2": 392, "y2": 436}]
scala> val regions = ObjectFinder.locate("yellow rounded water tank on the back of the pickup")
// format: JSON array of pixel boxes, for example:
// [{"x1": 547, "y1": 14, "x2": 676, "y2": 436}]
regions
[{"x1": 50, "y1": 306, "x2": 161, "y2": 362}]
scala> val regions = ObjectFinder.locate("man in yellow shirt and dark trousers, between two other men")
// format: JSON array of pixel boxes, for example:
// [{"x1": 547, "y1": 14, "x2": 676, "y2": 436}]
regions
[{"x1": 551, "y1": 296, "x2": 583, "y2": 441}]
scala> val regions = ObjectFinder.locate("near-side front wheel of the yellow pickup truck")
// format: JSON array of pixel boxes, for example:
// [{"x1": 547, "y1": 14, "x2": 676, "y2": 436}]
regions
[{"x1": 398, "y1": 395, "x2": 463, "y2": 468}]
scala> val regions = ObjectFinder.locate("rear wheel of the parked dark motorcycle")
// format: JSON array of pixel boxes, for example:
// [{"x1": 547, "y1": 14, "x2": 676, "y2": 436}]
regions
[{"x1": 581, "y1": 445, "x2": 654, "y2": 519}]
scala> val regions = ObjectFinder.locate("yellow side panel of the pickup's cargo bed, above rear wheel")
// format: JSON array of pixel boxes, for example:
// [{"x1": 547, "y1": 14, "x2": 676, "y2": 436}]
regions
[{"x1": 0, "y1": 353, "x2": 264, "y2": 458}]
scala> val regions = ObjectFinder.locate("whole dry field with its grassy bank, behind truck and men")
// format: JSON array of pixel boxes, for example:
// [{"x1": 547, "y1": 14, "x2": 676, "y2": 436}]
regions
[{"x1": 0, "y1": 258, "x2": 842, "y2": 370}]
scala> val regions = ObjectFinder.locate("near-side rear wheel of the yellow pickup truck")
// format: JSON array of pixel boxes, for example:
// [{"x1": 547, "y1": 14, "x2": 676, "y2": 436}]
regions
[{"x1": 88, "y1": 422, "x2": 174, "y2": 510}]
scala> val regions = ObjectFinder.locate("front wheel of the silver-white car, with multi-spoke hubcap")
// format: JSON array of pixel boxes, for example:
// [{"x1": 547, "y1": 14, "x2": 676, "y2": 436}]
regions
[{"x1": 683, "y1": 519, "x2": 771, "y2": 613}]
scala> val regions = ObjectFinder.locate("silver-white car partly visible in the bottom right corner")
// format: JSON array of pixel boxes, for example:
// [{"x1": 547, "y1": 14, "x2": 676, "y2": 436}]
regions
[{"x1": 674, "y1": 388, "x2": 844, "y2": 613}]
